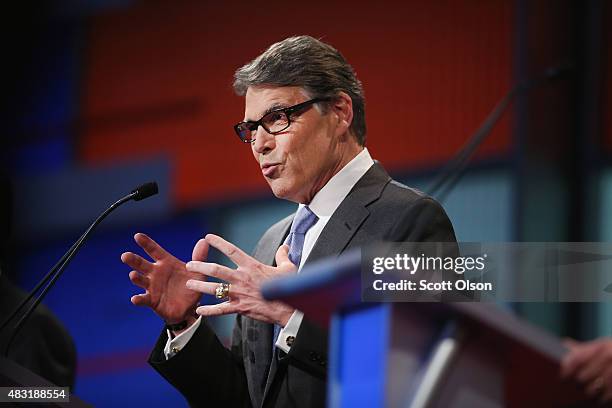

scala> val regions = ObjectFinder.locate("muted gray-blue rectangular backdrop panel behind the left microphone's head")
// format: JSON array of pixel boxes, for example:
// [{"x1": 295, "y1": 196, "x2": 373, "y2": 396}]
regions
[{"x1": 13, "y1": 159, "x2": 171, "y2": 242}]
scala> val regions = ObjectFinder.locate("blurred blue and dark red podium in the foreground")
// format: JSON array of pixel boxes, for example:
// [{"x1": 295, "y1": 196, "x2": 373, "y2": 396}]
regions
[{"x1": 262, "y1": 251, "x2": 591, "y2": 408}]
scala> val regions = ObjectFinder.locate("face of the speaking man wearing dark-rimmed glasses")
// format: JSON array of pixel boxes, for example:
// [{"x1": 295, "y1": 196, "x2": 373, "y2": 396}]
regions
[{"x1": 245, "y1": 86, "x2": 347, "y2": 204}]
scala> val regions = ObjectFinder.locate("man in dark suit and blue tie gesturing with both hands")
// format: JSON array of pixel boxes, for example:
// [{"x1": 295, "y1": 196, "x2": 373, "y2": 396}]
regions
[{"x1": 122, "y1": 36, "x2": 455, "y2": 407}]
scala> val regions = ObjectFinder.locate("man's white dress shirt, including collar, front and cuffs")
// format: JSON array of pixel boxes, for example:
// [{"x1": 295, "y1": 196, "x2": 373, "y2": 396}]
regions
[{"x1": 164, "y1": 148, "x2": 374, "y2": 358}]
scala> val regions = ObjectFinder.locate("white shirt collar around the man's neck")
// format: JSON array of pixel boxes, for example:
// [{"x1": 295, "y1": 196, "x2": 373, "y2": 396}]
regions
[{"x1": 300, "y1": 148, "x2": 374, "y2": 218}]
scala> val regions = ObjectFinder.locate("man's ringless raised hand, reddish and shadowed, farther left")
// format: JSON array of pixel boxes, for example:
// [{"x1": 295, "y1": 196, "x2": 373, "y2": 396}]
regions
[{"x1": 121, "y1": 233, "x2": 209, "y2": 324}]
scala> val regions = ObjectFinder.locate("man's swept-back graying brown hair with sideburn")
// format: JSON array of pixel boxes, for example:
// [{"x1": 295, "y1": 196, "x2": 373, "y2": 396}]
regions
[{"x1": 234, "y1": 35, "x2": 366, "y2": 146}]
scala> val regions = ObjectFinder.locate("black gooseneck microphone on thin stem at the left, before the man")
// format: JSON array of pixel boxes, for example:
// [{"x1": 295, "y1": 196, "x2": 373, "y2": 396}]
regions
[{"x1": 0, "y1": 182, "x2": 159, "y2": 357}]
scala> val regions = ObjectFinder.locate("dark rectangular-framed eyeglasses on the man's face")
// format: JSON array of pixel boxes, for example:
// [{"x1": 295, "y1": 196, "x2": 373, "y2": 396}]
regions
[{"x1": 234, "y1": 98, "x2": 330, "y2": 143}]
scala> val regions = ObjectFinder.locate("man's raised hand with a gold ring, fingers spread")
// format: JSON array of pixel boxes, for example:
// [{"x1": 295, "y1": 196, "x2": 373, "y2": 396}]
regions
[{"x1": 187, "y1": 234, "x2": 297, "y2": 327}]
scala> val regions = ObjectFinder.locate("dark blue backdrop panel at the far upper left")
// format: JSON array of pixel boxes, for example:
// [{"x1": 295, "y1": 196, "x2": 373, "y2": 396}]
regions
[{"x1": 0, "y1": 21, "x2": 83, "y2": 174}]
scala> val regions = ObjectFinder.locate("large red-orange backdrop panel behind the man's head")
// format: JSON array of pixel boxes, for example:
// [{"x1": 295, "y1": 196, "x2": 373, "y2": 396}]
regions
[{"x1": 79, "y1": 0, "x2": 512, "y2": 206}]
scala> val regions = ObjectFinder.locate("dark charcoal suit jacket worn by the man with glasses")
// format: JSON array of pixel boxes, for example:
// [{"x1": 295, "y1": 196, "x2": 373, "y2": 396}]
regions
[{"x1": 149, "y1": 164, "x2": 455, "y2": 407}]
